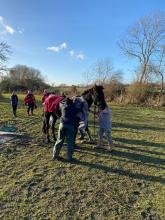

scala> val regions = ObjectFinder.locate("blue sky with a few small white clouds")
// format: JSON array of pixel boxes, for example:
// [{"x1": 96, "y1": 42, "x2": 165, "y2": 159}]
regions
[{"x1": 0, "y1": 0, "x2": 165, "y2": 84}]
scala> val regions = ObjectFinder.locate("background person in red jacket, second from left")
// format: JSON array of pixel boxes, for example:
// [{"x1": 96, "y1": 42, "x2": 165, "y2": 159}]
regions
[{"x1": 24, "y1": 90, "x2": 36, "y2": 115}]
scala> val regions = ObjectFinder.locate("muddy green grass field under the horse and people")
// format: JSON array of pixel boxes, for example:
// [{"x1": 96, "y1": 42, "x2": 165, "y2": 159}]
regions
[{"x1": 0, "y1": 95, "x2": 165, "y2": 220}]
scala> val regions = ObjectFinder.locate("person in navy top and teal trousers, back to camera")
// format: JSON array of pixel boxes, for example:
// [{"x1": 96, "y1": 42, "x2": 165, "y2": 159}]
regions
[{"x1": 53, "y1": 98, "x2": 80, "y2": 161}]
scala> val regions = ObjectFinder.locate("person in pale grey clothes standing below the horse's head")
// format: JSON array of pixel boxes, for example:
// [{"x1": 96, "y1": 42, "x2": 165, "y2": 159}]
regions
[{"x1": 95, "y1": 105, "x2": 113, "y2": 151}]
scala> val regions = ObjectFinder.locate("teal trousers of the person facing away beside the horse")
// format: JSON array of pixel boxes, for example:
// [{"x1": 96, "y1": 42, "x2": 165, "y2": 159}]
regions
[{"x1": 53, "y1": 123, "x2": 75, "y2": 160}]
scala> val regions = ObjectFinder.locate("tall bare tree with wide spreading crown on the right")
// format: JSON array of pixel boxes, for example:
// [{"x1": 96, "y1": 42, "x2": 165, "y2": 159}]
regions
[{"x1": 119, "y1": 13, "x2": 165, "y2": 83}]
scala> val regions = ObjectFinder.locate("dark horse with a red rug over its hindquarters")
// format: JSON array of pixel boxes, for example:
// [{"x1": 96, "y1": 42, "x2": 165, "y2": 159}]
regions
[{"x1": 42, "y1": 85, "x2": 106, "y2": 143}]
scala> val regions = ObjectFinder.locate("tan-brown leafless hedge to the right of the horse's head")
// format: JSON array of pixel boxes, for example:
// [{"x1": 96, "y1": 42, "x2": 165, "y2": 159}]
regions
[{"x1": 104, "y1": 82, "x2": 165, "y2": 106}]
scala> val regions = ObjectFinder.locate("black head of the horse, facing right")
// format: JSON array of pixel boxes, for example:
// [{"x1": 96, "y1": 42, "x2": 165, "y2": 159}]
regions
[{"x1": 92, "y1": 85, "x2": 106, "y2": 109}]
